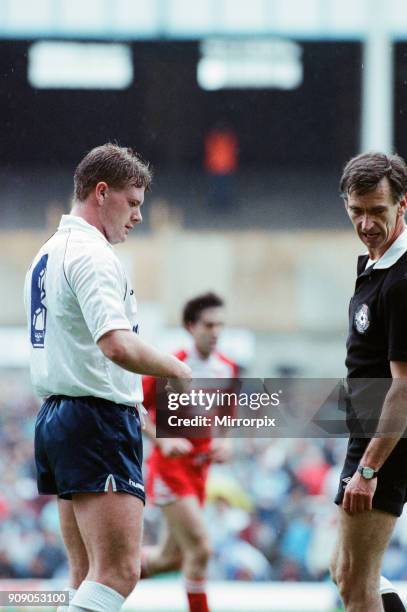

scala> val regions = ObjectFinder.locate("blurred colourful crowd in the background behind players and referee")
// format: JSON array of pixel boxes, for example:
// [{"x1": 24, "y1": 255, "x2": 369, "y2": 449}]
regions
[{"x1": 0, "y1": 372, "x2": 407, "y2": 581}]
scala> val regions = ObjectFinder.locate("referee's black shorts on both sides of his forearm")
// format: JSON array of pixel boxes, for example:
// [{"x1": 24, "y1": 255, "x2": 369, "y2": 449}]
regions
[{"x1": 335, "y1": 438, "x2": 407, "y2": 516}]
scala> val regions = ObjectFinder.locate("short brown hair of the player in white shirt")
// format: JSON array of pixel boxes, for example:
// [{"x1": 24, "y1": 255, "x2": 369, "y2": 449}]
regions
[{"x1": 74, "y1": 142, "x2": 152, "y2": 202}]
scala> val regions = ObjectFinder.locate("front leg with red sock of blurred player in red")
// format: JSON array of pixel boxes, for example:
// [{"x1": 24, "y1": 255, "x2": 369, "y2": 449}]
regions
[{"x1": 163, "y1": 496, "x2": 211, "y2": 612}]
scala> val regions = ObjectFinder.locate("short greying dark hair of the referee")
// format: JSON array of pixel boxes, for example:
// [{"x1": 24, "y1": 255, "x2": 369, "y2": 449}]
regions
[{"x1": 340, "y1": 152, "x2": 407, "y2": 204}]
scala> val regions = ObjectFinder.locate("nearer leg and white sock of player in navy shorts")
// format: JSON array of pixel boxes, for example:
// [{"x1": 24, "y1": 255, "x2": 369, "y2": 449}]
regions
[{"x1": 69, "y1": 490, "x2": 143, "y2": 612}]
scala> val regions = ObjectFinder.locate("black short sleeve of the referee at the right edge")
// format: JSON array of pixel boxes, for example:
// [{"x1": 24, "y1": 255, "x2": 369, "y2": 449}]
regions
[{"x1": 385, "y1": 279, "x2": 407, "y2": 361}]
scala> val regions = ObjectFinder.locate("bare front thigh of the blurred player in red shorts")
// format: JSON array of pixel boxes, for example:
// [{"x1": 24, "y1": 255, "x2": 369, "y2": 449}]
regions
[{"x1": 162, "y1": 495, "x2": 208, "y2": 550}]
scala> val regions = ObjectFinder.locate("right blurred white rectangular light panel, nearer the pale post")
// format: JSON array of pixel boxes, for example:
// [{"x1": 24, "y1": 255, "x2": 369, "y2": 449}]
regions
[{"x1": 197, "y1": 38, "x2": 303, "y2": 91}]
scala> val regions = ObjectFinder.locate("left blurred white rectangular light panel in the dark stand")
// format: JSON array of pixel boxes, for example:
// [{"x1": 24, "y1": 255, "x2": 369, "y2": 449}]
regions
[{"x1": 28, "y1": 41, "x2": 133, "y2": 89}]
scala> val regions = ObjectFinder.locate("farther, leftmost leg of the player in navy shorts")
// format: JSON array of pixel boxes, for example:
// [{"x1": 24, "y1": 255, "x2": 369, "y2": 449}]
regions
[{"x1": 58, "y1": 498, "x2": 89, "y2": 612}]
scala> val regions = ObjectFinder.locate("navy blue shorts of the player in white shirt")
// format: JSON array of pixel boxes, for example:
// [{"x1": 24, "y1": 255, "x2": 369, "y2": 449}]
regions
[{"x1": 35, "y1": 395, "x2": 145, "y2": 502}]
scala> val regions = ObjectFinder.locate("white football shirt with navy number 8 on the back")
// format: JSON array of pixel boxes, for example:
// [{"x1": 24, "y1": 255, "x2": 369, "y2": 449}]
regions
[{"x1": 24, "y1": 215, "x2": 143, "y2": 406}]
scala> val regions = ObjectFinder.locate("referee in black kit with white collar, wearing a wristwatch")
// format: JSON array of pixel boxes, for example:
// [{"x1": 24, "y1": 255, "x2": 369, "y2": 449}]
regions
[{"x1": 331, "y1": 153, "x2": 407, "y2": 612}]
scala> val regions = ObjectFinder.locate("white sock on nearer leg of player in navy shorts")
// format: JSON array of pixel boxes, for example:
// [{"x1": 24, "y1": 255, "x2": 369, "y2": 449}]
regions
[{"x1": 68, "y1": 580, "x2": 126, "y2": 612}]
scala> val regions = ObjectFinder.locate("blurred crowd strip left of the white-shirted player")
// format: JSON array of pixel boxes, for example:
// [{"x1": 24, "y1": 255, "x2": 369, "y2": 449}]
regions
[{"x1": 0, "y1": 371, "x2": 66, "y2": 578}]
